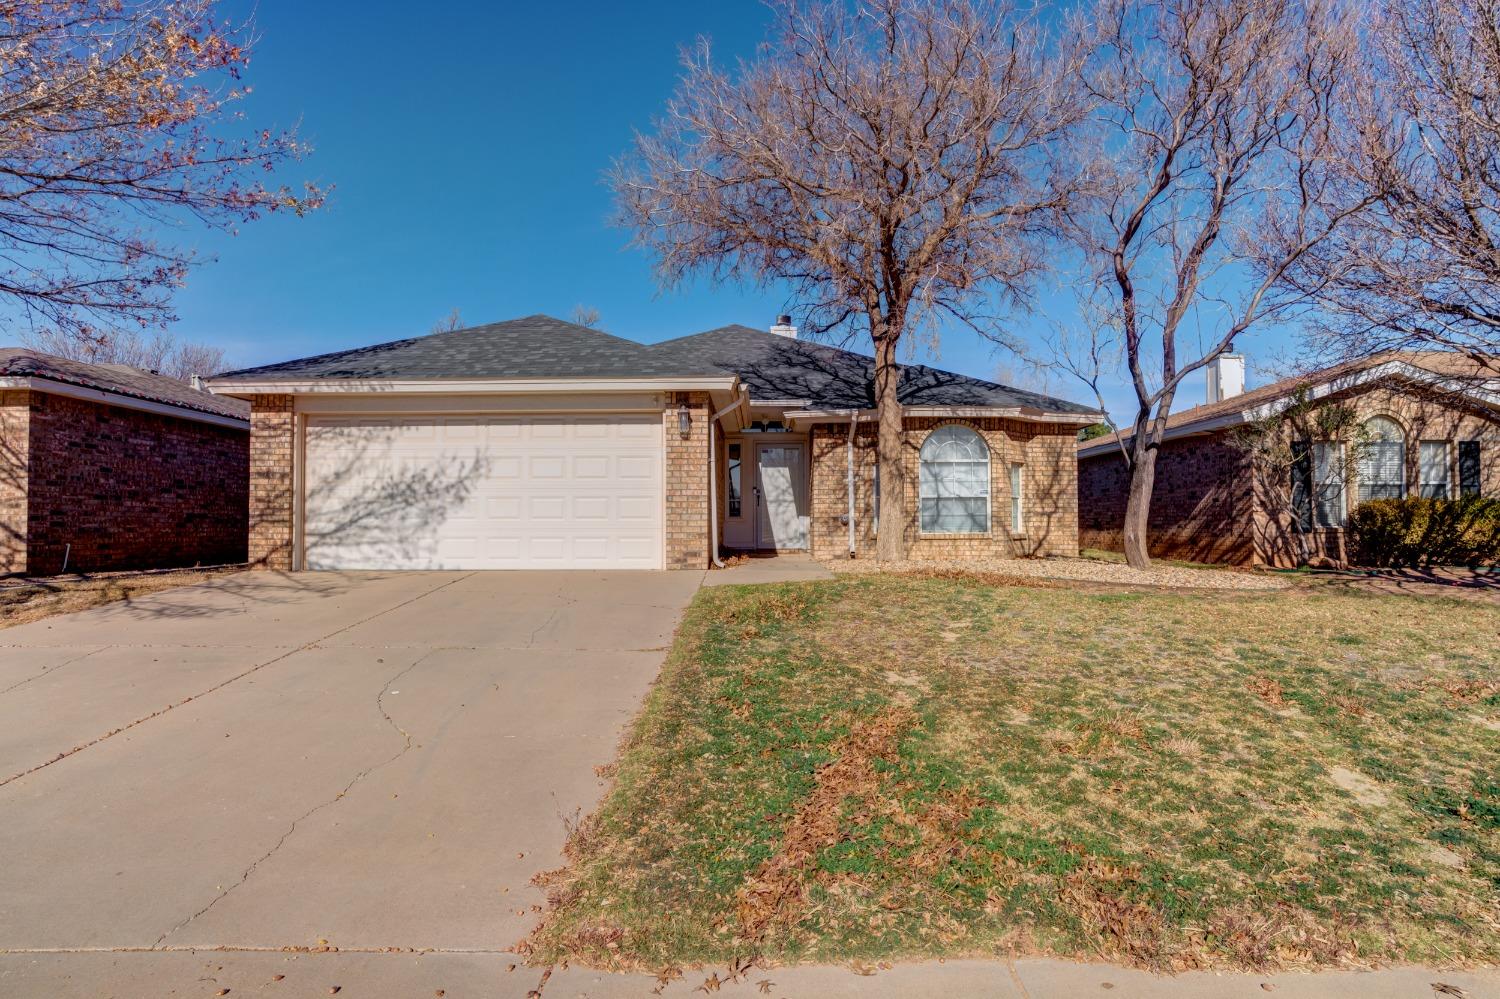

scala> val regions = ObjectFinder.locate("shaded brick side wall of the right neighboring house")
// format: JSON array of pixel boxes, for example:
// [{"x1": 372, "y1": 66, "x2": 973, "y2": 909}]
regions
[{"x1": 1079, "y1": 434, "x2": 1256, "y2": 564}]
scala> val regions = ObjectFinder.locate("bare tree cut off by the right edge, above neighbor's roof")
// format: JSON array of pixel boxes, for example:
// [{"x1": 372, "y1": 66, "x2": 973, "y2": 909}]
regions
[{"x1": 1289, "y1": 0, "x2": 1500, "y2": 360}]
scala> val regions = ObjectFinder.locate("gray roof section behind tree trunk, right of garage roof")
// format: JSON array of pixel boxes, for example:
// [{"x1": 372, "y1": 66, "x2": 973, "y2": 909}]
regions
[{"x1": 651, "y1": 326, "x2": 1097, "y2": 416}]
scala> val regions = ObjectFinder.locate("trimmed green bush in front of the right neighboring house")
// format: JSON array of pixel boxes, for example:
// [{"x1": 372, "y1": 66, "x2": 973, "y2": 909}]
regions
[{"x1": 1349, "y1": 497, "x2": 1500, "y2": 567}]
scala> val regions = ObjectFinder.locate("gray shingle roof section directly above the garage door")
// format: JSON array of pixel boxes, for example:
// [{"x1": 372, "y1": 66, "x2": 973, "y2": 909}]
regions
[{"x1": 215, "y1": 315, "x2": 723, "y2": 383}]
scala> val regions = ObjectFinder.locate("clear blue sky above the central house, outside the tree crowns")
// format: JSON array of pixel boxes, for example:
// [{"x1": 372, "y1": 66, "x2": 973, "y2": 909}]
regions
[{"x1": 164, "y1": 0, "x2": 1290, "y2": 417}]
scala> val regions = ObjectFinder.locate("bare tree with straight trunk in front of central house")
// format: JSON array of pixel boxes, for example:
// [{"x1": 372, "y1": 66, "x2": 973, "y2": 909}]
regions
[{"x1": 614, "y1": 0, "x2": 1086, "y2": 560}]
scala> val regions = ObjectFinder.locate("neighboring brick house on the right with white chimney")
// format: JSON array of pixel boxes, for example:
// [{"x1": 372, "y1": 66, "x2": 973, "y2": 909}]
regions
[{"x1": 1077, "y1": 353, "x2": 1500, "y2": 566}]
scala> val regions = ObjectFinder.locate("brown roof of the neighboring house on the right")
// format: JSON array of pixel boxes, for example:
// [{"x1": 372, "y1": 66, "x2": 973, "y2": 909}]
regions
[{"x1": 1079, "y1": 351, "x2": 1500, "y2": 458}]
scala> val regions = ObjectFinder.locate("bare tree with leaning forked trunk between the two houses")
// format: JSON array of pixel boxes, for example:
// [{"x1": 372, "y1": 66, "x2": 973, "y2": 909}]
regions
[{"x1": 1065, "y1": 0, "x2": 1367, "y2": 567}]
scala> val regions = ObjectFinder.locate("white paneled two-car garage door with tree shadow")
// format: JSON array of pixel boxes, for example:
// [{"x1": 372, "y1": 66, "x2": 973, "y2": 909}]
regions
[{"x1": 303, "y1": 416, "x2": 663, "y2": 569}]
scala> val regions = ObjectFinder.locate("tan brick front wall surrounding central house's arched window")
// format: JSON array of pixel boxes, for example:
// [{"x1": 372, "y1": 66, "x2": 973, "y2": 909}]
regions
[{"x1": 809, "y1": 417, "x2": 1079, "y2": 558}]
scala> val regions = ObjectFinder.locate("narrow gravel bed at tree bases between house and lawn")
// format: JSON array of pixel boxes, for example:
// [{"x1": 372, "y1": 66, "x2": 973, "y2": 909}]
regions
[{"x1": 825, "y1": 558, "x2": 1292, "y2": 590}]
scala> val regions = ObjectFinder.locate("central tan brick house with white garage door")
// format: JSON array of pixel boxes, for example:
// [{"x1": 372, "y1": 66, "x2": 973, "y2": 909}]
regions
[{"x1": 209, "y1": 317, "x2": 1098, "y2": 569}]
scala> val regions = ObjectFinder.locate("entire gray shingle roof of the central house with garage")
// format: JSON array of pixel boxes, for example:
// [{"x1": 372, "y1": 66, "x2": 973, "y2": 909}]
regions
[{"x1": 215, "y1": 315, "x2": 1094, "y2": 414}]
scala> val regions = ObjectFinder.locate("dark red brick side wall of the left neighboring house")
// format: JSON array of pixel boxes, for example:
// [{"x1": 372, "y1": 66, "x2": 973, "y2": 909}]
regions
[{"x1": 27, "y1": 392, "x2": 249, "y2": 575}]
